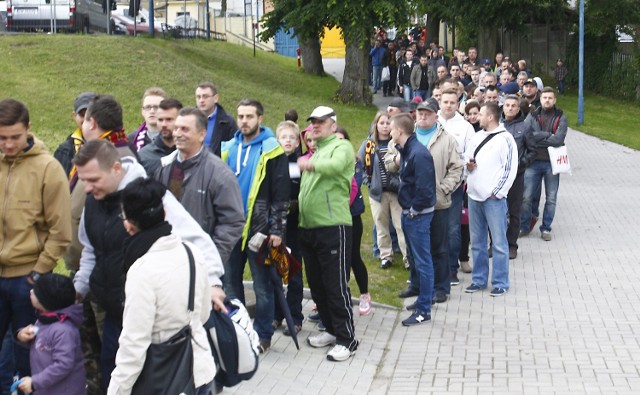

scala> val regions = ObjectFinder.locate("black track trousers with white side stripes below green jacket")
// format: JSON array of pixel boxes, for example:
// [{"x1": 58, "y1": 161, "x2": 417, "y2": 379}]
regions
[{"x1": 300, "y1": 225, "x2": 358, "y2": 351}]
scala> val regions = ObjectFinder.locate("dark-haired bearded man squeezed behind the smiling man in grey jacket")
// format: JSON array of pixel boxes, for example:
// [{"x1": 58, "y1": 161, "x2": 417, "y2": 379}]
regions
[{"x1": 138, "y1": 99, "x2": 182, "y2": 177}]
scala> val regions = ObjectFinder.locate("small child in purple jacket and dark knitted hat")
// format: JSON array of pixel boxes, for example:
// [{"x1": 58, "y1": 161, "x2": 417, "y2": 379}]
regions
[{"x1": 17, "y1": 274, "x2": 86, "y2": 395}]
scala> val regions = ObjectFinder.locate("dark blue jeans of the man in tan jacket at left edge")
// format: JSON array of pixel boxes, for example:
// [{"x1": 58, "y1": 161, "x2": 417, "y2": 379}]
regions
[{"x1": 0, "y1": 276, "x2": 36, "y2": 377}]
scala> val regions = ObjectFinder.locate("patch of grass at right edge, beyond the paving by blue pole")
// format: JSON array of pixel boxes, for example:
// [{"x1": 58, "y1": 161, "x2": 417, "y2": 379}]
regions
[{"x1": 557, "y1": 92, "x2": 640, "y2": 150}]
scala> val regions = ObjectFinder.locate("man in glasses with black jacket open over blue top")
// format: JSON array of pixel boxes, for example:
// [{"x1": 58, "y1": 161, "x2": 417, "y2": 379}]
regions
[{"x1": 196, "y1": 81, "x2": 238, "y2": 156}]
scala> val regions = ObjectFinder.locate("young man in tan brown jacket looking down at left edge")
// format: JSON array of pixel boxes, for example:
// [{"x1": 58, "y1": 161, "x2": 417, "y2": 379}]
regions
[{"x1": 0, "y1": 99, "x2": 71, "y2": 377}]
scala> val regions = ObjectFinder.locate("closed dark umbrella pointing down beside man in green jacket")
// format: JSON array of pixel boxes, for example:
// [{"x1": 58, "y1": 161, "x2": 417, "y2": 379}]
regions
[{"x1": 257, "y1": 239, "x2": 302, "y2": 350}]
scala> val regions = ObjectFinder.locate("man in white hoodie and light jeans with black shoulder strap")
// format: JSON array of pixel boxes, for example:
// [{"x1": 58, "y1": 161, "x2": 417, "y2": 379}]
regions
[{"x1": 464, "y1": 103, "x2": 518, "y2": 296}]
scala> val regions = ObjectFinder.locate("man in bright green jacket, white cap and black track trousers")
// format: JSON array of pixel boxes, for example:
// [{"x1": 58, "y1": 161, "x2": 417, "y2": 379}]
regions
[{"x1": 298, "y1": 106, "x2": 358, "y2": 361}]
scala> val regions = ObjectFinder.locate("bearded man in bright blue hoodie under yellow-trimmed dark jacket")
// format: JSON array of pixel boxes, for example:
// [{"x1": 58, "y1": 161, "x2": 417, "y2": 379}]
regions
[{"x1": 222, "y1": 99, "x2": 291, "y2": 353}]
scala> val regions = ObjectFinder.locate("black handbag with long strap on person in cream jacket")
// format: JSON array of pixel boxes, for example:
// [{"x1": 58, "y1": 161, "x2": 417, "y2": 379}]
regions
[{"x1": 131, "y1": 244, "x2": 196, "y2": 395}]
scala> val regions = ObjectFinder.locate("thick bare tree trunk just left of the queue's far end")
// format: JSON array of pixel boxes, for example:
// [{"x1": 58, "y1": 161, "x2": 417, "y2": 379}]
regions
[{"x1": 336, "y1": 37, "x2": 372, "y2": 104}]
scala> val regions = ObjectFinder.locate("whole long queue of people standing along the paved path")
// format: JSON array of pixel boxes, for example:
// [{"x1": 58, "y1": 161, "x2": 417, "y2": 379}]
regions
[{"x1": 0, "y1": 29, "x2": 567, "y2": 394}]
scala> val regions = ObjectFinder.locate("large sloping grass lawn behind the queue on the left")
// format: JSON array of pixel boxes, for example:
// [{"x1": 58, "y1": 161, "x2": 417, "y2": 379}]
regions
[{"x1": 0, "y1": 34, "x2": 407, "y2": 306}]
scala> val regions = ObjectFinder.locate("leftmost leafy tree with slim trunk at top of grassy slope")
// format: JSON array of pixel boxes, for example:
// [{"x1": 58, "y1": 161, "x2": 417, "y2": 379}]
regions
[{"x1": 260, "y1": 0, "x2": 331, "y2": 76}]
